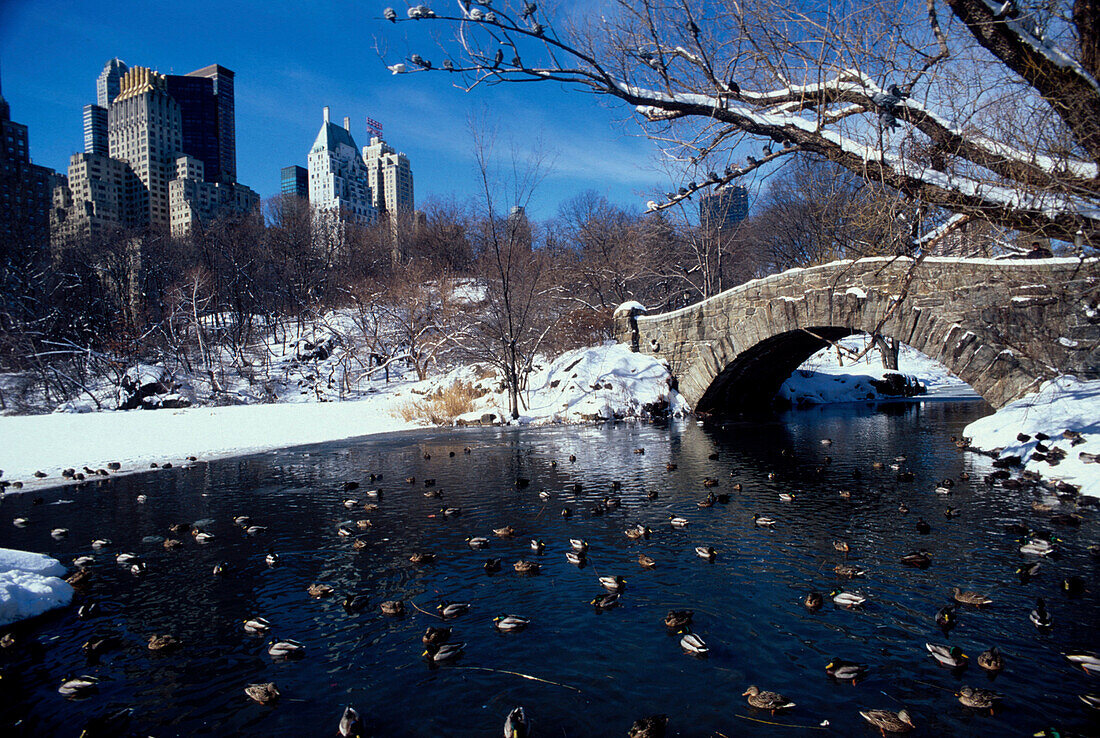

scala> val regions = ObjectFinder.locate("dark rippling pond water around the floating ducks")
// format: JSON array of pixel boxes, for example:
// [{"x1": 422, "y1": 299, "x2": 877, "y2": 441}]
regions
[{"x1": 0, "y1": 401, "x2": 1100, "y2": 736}]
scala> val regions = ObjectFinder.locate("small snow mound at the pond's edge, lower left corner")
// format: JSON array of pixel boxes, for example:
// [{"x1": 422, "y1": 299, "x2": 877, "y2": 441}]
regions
[{"x1": 0, "y1": 549, "x2": 73, "y2": 626}]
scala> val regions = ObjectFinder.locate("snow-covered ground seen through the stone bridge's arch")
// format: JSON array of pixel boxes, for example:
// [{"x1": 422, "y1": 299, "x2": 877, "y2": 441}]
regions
[{"x1": 779, "y1": 334, "x2": 975, "y2": 407}]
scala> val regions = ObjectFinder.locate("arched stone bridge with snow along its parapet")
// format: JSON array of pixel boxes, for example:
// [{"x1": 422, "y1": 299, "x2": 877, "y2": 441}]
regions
[{"x1": 615, "y1": 257, "x2": 1100, "y2": 411}]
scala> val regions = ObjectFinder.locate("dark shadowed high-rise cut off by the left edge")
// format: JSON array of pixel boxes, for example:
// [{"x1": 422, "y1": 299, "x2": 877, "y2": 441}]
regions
[{"x1": 0, "y1": 73, "x2": 55, "y2": 245}]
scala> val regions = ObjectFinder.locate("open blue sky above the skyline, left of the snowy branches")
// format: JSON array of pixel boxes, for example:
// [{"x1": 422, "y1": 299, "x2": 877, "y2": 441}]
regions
[{"x1": 0, "y1": 0, "x2": 668, "y2": 218}]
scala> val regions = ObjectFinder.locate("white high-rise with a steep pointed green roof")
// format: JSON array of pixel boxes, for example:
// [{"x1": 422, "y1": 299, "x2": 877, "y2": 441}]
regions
[{"x1": 309, "y1": 107, "x2": 378, "y2": 223}]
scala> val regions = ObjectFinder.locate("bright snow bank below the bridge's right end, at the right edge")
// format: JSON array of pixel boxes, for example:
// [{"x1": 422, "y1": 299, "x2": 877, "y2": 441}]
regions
[{"x1": 963, "y1": 376, "x2": 1100, "y2": 497}]
